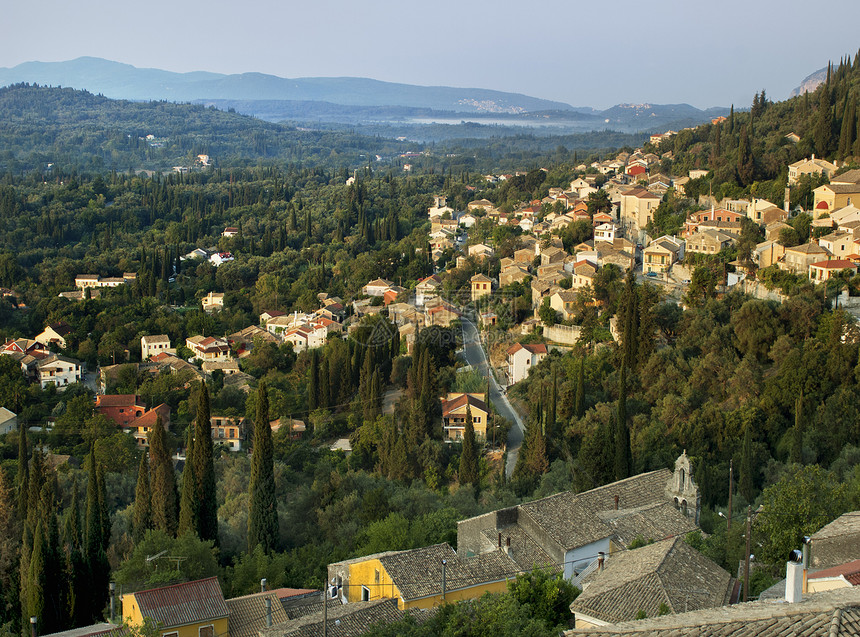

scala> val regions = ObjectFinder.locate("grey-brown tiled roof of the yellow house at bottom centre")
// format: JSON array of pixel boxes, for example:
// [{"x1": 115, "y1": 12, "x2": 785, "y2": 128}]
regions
[{"x1": 379, "y1": 544, "x2": 521, "y2": 601}]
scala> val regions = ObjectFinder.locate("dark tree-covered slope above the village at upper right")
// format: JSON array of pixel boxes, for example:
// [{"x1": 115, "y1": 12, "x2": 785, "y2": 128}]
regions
[{"x1": 640, "y1": 52, "x2": 860, "y2": 206}]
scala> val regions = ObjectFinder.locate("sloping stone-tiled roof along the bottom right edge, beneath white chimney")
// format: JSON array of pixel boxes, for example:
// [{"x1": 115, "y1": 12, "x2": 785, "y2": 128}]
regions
[{"x1": 565, "y1": 588, "x2": 860, "y2": 637}]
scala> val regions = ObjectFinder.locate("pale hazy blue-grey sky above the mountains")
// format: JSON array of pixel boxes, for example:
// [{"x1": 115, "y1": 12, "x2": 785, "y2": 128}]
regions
[{"x1": 0, "y1": 0, "x2": 860, "y2": 108}]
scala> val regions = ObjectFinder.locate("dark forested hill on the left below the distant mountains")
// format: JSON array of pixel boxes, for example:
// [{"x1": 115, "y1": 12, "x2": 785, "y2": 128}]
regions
[{"x1": 0, "y1": 84, "x2": 416, "y2": 173}]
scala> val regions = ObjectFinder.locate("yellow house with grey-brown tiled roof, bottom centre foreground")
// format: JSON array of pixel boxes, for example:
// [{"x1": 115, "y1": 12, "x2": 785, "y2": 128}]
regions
[{"x1": 328, "y1": 544, "x2": 520, "y2": 610}]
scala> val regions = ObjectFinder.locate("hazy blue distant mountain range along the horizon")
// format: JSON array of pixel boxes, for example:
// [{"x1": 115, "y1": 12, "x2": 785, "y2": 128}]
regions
[{"x1": 0, "y1": 57, "x2": 728, "y2": 134}]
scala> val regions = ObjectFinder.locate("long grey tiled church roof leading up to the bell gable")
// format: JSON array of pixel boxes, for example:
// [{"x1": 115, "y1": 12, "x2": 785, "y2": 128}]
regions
[{"x1": 519, "y1": 469, "x2": 672, "y2": 550}]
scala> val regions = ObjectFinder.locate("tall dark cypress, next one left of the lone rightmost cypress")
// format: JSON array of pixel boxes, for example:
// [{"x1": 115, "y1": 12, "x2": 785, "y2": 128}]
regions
[{"x1": 192, "y1": 382, "x2": 218, "y2": 546}]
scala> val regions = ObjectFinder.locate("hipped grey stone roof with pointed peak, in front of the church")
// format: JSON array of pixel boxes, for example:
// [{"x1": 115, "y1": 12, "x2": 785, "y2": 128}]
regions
[{"x1": 570, "y1": 537, "x2": 734, "y2": 624}]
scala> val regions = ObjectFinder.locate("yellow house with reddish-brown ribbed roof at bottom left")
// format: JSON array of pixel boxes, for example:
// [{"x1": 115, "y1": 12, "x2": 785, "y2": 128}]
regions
[{"x1": 122, "y1": 577, "x2": 230, "y2": 637}]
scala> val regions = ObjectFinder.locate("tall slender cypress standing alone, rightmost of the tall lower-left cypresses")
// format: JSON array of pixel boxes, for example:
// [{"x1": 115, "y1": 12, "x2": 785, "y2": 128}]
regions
[{"x1": 248, "y1": 382, "x2": 278, "y2": 553}]
